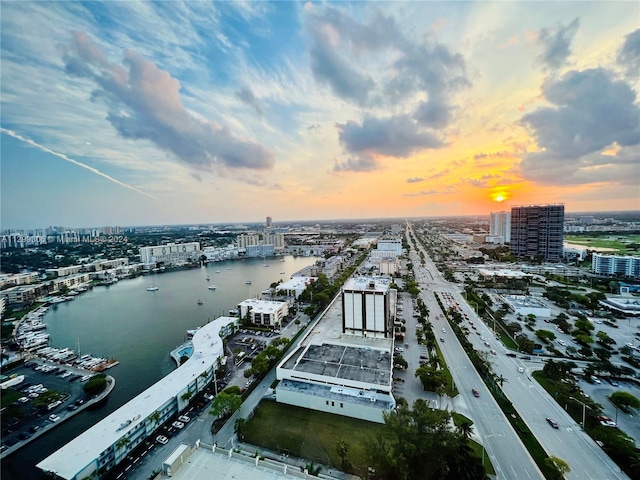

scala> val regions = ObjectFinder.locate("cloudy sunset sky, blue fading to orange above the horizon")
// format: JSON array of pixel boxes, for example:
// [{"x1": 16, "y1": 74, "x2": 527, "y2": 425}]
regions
[{"x1": 0, "y1": 1, "x2": 640, "y2": 229}]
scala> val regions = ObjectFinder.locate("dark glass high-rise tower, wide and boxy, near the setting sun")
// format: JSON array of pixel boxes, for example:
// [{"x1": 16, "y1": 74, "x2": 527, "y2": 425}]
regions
[{"x1": 510, "y1": 204, "x2": 564, "y2": 262}]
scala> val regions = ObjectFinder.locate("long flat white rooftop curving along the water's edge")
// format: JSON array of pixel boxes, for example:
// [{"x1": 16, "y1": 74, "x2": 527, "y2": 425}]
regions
[{"x1": 36, "y1": 317, "x2": 232, "y2": 479}]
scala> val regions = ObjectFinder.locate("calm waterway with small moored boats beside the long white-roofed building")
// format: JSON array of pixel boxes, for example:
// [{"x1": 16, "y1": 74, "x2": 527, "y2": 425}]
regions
[{"x1": 2, "y1": 256, "x2": 316, "y2": 480}]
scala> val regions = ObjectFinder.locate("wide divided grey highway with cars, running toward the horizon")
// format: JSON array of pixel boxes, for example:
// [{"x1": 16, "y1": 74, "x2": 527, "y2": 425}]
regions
[{"x1": 413, "y1": 224, "x2": 628, "y2": 480}]
